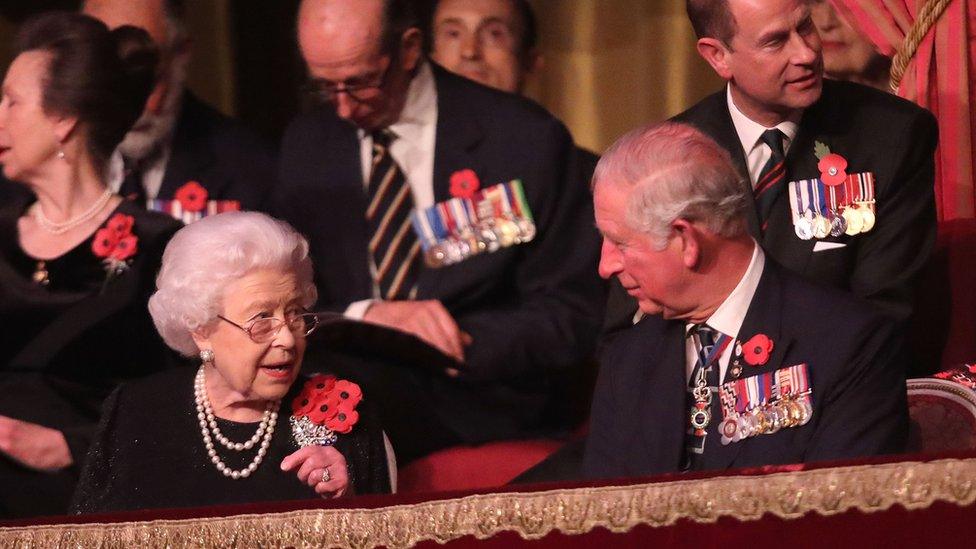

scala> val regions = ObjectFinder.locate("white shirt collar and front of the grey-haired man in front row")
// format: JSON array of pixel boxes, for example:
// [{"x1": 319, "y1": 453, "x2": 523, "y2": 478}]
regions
[{"x1": 685, "y1": 243, "x2": 766, "y2": 380}]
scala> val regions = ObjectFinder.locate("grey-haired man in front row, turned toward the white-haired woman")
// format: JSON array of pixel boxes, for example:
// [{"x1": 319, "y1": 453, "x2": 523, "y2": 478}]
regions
[{"x1": 583, "y1": 123, "x2": 908, "y2": 478}]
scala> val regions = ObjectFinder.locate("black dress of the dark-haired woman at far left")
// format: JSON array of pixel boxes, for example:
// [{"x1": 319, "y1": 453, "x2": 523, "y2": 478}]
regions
[{"x1": 0, "y1": 192, "x2": 181, "y2": 519}]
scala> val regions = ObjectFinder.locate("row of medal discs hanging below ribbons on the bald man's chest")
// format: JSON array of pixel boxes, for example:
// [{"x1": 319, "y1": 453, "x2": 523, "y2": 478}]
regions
[{"x1": 424, "y1": 216, "x2": 536, "y2": 268}]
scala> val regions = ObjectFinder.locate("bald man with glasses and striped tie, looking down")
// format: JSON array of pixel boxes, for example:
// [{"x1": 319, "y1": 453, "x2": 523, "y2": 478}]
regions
[{"x1": 274, "y1": 0, "x2": 603, "y2": 463}]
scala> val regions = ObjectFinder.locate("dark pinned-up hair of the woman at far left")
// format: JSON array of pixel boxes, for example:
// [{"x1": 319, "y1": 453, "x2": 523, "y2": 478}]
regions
[{"x1": 14, "y1": 11, "x2": 159, "y2": 168}]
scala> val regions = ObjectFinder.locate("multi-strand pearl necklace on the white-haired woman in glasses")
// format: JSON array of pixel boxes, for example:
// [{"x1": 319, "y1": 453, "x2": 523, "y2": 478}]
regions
[{"x1": 193, "y1": 366, "x2": 281, "y2": 480}]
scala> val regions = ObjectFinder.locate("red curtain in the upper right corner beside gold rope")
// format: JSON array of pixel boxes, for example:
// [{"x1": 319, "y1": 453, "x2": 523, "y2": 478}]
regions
[{"x1": 831, "y1": 0, "x2": 976, "y2": 221}]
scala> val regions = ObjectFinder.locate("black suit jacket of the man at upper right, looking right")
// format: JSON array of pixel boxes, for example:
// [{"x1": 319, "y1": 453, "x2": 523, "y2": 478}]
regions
[{"x1": 606, "y1": 80, "x2": 938, "y2": 330}]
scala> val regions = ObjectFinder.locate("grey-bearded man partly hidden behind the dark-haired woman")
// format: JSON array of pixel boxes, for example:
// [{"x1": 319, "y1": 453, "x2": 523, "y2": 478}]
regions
[{"x1": 82, "y1": 0, "x2": 275, "y2": 220}]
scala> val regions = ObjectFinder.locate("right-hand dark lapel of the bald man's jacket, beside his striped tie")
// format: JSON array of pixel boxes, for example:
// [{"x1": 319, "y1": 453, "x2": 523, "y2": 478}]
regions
[{"x1": 417, "y1": 63, "x2": 485, "y2": 298}]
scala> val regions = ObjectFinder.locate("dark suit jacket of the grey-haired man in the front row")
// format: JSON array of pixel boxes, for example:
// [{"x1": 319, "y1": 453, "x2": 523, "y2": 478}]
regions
[{"x1": 583, "y1": 257, "x2": 908, "y2": 478}]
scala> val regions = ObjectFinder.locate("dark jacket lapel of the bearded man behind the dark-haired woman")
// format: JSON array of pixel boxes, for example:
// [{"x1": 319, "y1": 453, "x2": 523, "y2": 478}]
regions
[{"x1": 158, "y1": 92, "x2": 219, "y2": 199}]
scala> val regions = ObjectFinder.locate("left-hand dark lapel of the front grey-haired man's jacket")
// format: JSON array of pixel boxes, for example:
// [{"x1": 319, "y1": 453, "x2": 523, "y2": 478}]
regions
[{"x1": 637, "y1": 318, "x2": 688, "y2": 473}]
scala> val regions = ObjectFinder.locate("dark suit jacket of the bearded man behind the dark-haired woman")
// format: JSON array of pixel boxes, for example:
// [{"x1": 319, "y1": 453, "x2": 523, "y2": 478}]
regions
[{"x1": 157, "y1": 92, "x2": 277, "y2": 210}]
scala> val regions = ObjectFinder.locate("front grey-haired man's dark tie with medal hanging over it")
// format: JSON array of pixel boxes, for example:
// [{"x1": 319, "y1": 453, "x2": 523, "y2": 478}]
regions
[{"x1": 685, "y1": 324, "x2": 729, "y2": 471}]
